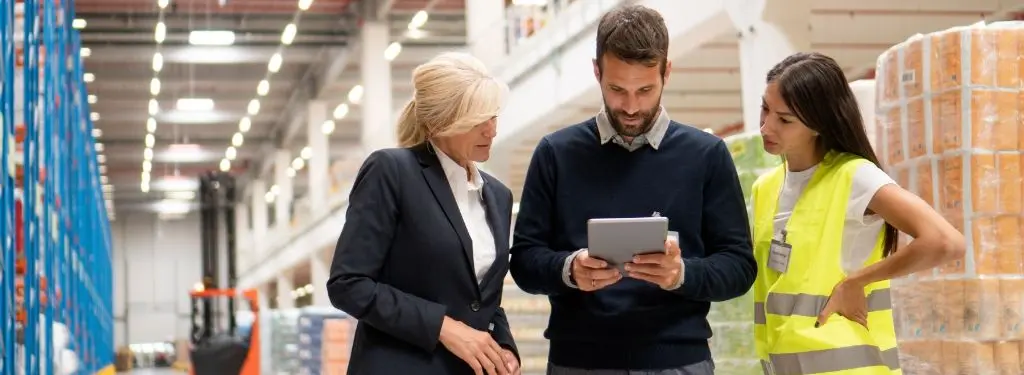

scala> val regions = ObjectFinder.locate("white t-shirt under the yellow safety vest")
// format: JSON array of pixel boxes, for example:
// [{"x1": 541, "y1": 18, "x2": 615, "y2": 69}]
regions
[{"x1": 773, "y1": 163, "x2": 896, "y2": 275}]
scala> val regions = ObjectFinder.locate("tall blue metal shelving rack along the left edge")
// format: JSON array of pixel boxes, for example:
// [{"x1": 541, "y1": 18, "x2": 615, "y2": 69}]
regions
[{"x1": 0, "y1": 0, "x2": 114, "y2": 375}]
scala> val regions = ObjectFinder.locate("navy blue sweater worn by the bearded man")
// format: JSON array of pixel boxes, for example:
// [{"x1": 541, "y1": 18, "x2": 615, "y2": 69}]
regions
[{"x1": 510, "y1": 119, "x2": 757, "y2": 370}]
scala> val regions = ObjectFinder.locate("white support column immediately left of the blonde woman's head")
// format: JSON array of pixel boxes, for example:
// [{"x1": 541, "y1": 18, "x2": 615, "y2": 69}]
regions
[{"x1": 359, "y1": 20, "x2": 397, "y2": 153}]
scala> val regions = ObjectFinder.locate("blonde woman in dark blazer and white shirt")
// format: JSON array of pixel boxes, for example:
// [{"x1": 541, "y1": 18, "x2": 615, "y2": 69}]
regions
[{"x1": 327, "y1": 53, "x2": 519, "y2": 375}]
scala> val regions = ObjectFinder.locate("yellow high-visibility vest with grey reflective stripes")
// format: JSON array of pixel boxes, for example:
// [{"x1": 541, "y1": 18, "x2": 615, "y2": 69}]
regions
[{"x1": 753, "y1": 152, "x2": 902, "y2": 375}]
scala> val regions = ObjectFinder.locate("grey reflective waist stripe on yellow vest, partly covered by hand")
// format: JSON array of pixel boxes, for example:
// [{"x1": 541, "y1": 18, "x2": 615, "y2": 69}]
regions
[{"x1": 754, "y1": 288, "x2": 893, "y2": 324}]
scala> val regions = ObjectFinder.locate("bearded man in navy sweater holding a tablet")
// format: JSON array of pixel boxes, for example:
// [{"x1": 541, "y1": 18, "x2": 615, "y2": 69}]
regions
[{"x1": 510, "y1": 6, "x2": 757, "y2": 375}]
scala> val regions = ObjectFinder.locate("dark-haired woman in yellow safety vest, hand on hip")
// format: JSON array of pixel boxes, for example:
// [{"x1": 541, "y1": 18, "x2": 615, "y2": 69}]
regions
[{"x1": 753, "y1": 53, "x2": 965, "y2": 375}]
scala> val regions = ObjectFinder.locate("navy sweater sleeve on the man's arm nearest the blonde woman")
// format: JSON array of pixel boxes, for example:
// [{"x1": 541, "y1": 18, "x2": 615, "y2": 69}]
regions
[{"x1": 509, "y1": 138, "x2": 573, "y2": 295}]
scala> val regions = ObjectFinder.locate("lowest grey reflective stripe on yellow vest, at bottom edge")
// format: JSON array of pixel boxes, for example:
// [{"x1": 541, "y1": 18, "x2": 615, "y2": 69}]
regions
[{"x1": 761, "y1": 345, "x2": 899, "y2": 375}]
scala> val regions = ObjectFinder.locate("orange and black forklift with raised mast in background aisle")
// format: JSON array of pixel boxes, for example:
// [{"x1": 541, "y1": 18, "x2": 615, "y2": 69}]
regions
[{"x1": 189, "y1": 172, "x2": 260, "y2": 375}]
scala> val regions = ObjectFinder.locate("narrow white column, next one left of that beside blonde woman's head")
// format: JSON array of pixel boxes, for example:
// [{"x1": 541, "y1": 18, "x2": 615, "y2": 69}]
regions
[{"x1": 306, "y1": 100, "x2": 331, "y2": 218}]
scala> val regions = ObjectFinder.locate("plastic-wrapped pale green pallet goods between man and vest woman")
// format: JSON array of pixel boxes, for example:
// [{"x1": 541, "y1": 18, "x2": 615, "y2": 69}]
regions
[{"x1": 708, "y1": 132, "x2": 781, "y2": 375}]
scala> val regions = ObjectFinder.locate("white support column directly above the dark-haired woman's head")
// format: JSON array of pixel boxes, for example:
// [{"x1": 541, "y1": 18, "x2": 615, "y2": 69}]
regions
[{"x1": 725, "y1": 0, "x2": 811, "y2": 132}]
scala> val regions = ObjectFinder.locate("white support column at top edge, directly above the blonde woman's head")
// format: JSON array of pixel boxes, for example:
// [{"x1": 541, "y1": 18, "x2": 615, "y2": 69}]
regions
[{"x1": 466, "y1": 1, "x2": 508, "y2": 70}]
